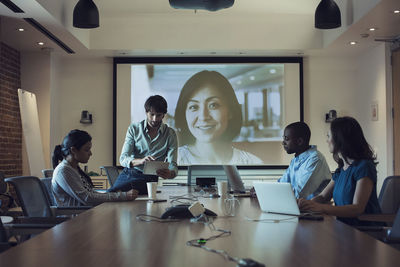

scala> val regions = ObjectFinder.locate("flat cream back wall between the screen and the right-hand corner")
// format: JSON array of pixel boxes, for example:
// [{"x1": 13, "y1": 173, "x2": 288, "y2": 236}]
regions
[{"x1": 304, "y1": 57, "x2": 356, "y2": 171}]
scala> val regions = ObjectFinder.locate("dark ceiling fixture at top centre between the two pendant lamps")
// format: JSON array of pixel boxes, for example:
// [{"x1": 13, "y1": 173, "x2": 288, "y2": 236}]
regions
[{"x1": 169, "y1": 0, "x2": 235, "y2": 11}]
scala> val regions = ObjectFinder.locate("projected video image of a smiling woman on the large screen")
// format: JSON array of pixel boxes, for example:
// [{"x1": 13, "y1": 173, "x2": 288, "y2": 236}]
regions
[{"x1": 124, "y1": 63, "x2": 299, "y2": 165}]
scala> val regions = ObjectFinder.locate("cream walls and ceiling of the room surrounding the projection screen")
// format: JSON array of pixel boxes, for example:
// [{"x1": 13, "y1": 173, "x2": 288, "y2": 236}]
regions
[{"x1": 0, "y1": 0, "x2": 400, "y2": 192}]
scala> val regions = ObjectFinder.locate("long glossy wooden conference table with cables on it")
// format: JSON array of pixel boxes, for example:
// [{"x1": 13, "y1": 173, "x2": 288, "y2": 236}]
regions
[{"x1": 0, "y1": 186, "x2": 400, "y2": 267}]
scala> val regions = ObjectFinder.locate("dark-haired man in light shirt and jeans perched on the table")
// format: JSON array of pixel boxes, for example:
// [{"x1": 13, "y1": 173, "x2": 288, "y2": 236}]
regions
[{"x1": 108, "y1": 95, "x2": 178, "y2": 194}]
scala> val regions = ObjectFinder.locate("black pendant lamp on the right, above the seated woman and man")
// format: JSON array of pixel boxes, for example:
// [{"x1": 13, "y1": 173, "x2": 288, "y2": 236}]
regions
[{"x1": 315, "y1": 0, "x2": 342, "y2": 29}]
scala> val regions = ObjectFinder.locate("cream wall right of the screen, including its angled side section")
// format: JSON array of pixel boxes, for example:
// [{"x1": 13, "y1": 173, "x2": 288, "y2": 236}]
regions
[{"x1": 304, "y1": 44, "x2": 392, "y2": 192}]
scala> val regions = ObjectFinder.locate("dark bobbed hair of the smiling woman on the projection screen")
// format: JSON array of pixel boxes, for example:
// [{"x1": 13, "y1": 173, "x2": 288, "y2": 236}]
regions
[{"x1": 175, "y1": 70, "x2": 242, "y2": 146}]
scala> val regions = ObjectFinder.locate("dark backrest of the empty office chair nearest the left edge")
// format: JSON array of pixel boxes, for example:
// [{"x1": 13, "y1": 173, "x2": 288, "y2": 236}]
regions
[{"x1": 5, "y1": 176, "x2": 52, "y2": 217}]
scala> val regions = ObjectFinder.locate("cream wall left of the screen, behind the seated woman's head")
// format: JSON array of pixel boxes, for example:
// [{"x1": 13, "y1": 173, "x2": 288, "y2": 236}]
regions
[{"x1": 51, "y1": 57, "x2": 112, "y2": 172}]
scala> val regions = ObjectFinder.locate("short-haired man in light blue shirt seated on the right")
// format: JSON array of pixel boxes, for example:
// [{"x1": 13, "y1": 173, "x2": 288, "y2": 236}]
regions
[{"x1": 278, "y1": 122, "x2": 332, "y2": 199}]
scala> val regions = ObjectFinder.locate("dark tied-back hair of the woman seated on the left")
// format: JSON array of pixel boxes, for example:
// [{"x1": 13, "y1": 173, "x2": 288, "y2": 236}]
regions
[{"x1": 52, "y1": 129, "x2": 92, "y2": 168}]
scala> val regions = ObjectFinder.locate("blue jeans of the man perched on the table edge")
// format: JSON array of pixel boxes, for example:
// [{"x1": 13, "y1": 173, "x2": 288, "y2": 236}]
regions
[{"x1": 107, "y1": 168, "x2": 158, "y2": 195}]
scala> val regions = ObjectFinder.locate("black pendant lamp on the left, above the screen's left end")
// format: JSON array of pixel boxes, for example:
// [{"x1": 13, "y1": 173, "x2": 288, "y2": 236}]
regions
[{"x1": 73, "y1": 0, "x2": 99, "y2": 29}]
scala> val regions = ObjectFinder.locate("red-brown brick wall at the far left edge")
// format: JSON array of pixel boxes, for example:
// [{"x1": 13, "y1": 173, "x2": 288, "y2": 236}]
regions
[{"x1": 0, "y1": 43, "x2": 22, "y2": 177}]
